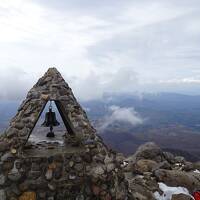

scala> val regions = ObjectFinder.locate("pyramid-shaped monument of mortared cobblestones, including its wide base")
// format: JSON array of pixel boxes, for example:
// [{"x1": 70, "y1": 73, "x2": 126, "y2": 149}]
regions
[{"x1": 0, "y1": 68, "x2": 129, "y2": 200}]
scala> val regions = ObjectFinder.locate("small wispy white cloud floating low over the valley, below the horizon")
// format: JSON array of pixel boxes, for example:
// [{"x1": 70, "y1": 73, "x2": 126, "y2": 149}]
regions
[{"x1": 100, "y1": 105, "x2": 144, "y2": 130}]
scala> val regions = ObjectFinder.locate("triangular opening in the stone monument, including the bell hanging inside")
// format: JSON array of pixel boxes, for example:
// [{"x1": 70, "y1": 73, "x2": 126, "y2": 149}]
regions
[{"x1": 23, "y1": 100, "x2": 84, "y2": 157}]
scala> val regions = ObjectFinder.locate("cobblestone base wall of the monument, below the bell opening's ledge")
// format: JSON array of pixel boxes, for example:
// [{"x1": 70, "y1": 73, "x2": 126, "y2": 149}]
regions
[{"x1": 0, "y1": 140, "x2": 128, "y2": 200}]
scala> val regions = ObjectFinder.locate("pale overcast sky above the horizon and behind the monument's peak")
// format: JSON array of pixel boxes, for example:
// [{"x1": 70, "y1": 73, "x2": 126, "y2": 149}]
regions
[{"x1": 0, "y1": 0, "x2": 200, "y2": 100}]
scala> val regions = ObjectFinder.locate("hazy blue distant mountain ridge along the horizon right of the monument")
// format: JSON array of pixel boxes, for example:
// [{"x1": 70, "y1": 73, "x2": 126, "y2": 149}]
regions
[{"x1": 82, "y1": 93, "x2": 200, "y2": 130}]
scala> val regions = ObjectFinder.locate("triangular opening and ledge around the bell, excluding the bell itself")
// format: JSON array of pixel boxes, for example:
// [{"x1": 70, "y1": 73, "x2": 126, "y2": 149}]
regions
[{"x1": 22, "y1": 101, "x2": 84, "y2": 157}]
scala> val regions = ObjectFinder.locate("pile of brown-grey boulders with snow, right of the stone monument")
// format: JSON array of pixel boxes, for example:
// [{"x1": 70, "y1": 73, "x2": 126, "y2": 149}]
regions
[{"x1": 124, "y1": 143, "x2": 200, "y2": 200}]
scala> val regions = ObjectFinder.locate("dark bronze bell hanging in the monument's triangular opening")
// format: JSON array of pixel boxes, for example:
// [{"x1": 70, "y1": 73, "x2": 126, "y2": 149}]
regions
[{"x1": 42, "y1": 101, "x2": 60, "y2": 137}]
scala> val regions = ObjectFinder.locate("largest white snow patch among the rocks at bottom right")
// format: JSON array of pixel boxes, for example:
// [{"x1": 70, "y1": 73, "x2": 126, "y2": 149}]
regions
[{"x1": 154, "y1": 183, "x2": 193, "y2": 200}]
